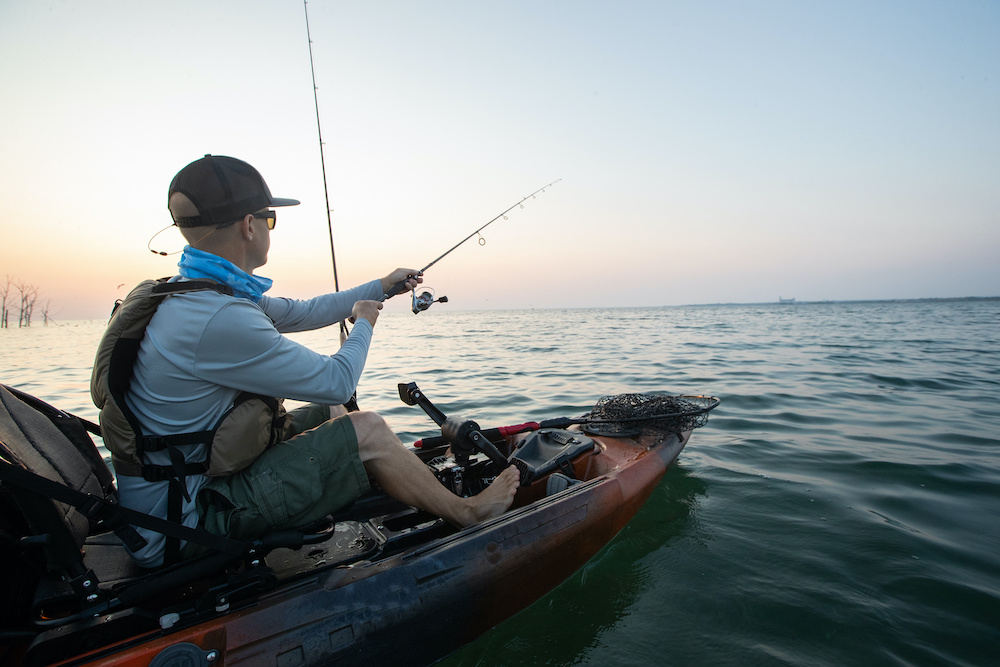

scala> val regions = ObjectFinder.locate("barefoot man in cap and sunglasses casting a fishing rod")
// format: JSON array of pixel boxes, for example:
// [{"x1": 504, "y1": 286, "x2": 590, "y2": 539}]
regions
[{"x1": 95, "y1": 155, "x2": 518, "y2": 567}]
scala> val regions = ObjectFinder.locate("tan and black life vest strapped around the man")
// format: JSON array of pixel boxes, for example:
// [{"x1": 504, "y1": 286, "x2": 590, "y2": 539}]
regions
[{"x1": 90, "y1": 278, "x2": 291, "y2": 486}]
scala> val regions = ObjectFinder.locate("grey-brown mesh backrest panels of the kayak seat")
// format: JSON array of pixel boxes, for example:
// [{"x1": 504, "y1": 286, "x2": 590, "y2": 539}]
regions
[{"x1": 0, "y1": 387, "x2": 104, "y2": 548}]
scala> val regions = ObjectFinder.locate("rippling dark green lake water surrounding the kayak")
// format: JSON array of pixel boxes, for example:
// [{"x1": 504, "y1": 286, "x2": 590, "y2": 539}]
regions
[{"x1": 0, "y1": 300, "x2": 1000, "y2": 667}]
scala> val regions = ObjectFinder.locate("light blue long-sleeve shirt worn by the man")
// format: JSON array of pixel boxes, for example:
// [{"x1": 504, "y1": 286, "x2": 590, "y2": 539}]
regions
[{"x1": 118, "y1": 278, "x2": 382, "y2": 567}]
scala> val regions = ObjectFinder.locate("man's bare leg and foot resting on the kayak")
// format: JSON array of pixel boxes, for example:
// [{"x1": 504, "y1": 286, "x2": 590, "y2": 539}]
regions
[{"x1": 348, "y1": 412, "x2": 519, "y2": 527}]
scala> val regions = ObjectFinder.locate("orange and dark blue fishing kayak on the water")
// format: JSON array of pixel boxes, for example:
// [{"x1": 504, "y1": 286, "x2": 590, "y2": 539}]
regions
[{"x1": 0, "y1": 384, "x2": 719, "y2": 667}]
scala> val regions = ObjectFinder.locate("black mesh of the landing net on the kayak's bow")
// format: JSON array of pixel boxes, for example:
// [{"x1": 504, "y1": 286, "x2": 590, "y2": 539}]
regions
[{"x1": 585, "y1": 394, "x2": 719, "y2": 435}]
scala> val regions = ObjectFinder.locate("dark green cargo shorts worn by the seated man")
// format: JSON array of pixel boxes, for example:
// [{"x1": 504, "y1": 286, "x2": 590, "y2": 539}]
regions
[{"x1": 181, "y1": 404, "x2": 371, "y2": 558}]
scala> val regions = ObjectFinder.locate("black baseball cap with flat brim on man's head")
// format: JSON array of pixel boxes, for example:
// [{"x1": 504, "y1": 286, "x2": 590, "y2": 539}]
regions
[{"x1": 167, "y1": 155, "x2": 299, "y2": 227}]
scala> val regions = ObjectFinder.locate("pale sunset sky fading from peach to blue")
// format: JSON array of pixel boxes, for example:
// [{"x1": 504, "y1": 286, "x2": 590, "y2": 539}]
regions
[{"x1": 0, "y1": 0, "x2": 1000, "y2": 320}]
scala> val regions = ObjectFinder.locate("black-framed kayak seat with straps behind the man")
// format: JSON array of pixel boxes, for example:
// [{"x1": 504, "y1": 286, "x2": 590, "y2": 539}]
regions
[{"x1": 0, "y1": 385, "x2": 333, "y2": 664}]
